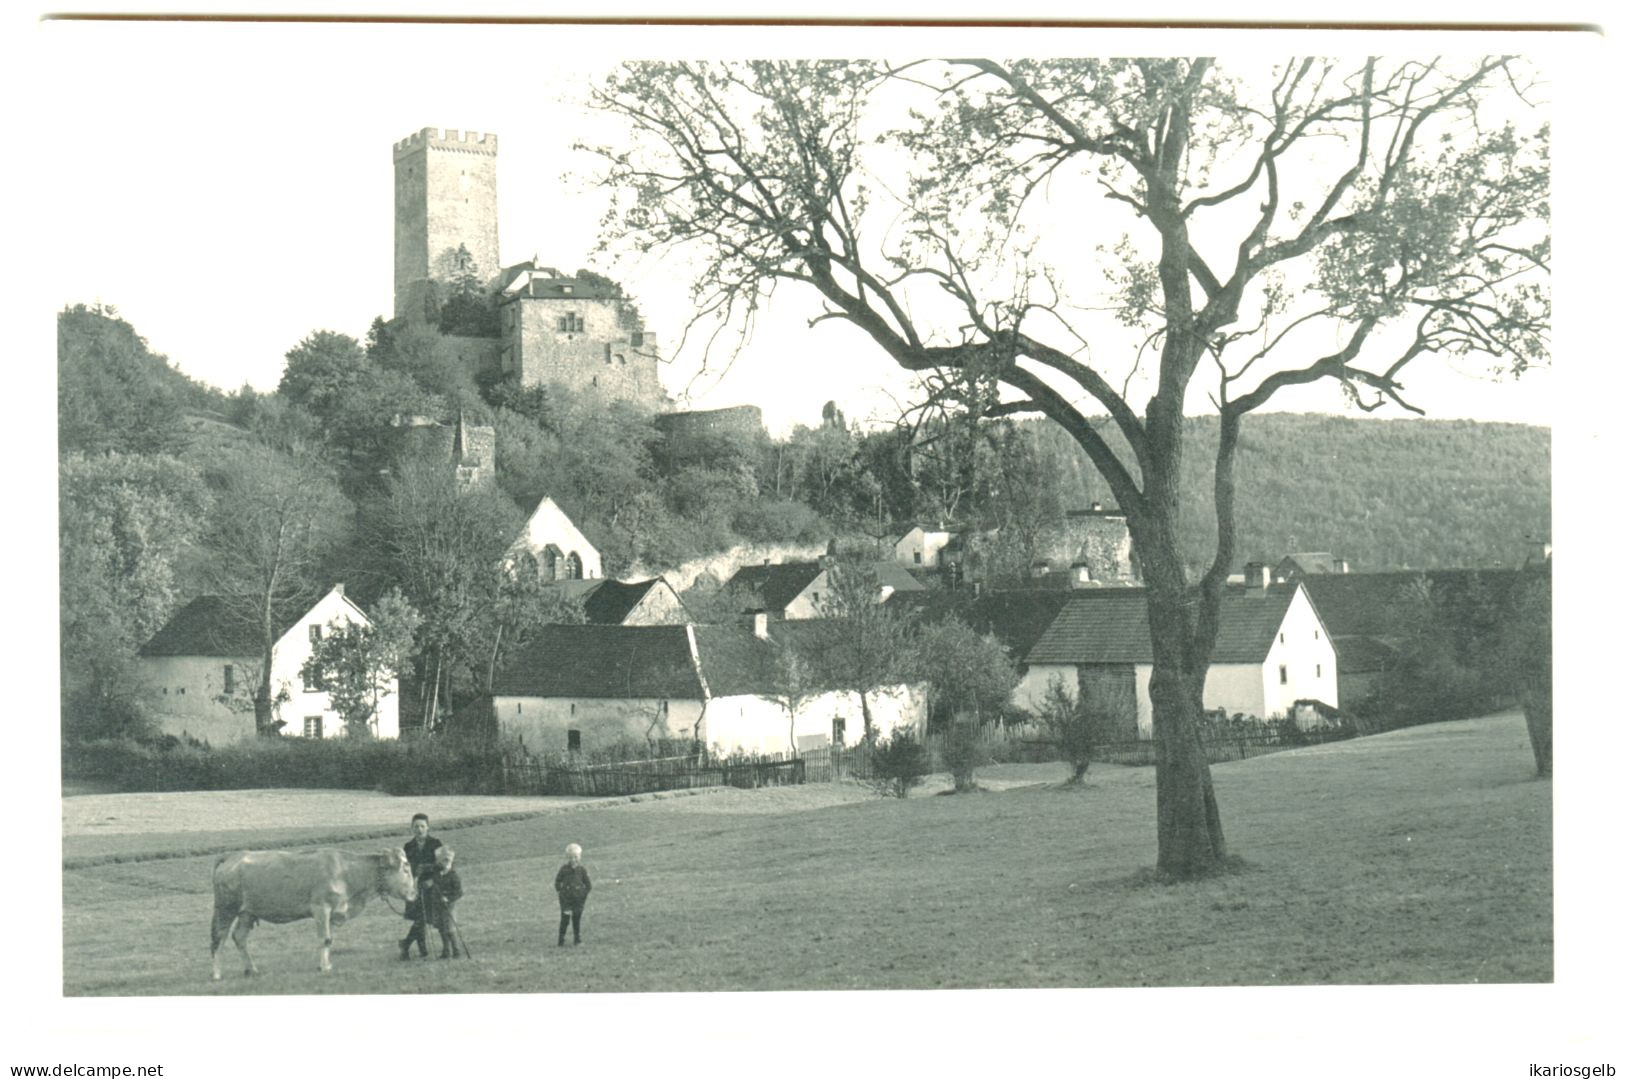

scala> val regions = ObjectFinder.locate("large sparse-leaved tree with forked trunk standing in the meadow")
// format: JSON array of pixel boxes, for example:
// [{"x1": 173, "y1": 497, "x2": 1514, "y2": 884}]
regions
[{"x1": 595, "y1": 57, "x2": 1549, "y2": 879}]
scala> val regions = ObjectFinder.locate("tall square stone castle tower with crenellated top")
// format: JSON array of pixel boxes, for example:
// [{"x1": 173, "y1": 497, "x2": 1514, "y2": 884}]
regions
[{"x1": 395, "y1": 127, "x2": 502, "y2": 319}]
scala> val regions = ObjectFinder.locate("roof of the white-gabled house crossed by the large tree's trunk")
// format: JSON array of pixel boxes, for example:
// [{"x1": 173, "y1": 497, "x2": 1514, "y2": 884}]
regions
[{"x1": 1027, "y1": 583, "x2": 1300, "y2": 663}]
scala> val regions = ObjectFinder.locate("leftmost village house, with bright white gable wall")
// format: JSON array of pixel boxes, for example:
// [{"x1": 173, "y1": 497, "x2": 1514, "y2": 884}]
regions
[{"x1": 137, "y1": 585, "x2": 400, "y2": 746}]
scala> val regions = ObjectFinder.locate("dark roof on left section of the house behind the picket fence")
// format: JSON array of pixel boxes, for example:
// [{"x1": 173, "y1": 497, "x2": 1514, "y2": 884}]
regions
[{"x1": 491, "y1": 626, "x2": 704, "y2": 700}]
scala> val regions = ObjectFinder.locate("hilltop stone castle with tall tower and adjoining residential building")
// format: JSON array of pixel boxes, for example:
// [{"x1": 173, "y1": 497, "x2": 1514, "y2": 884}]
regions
[{"x1": 395, "y1": 127, "x2": 671, "y2": 413}]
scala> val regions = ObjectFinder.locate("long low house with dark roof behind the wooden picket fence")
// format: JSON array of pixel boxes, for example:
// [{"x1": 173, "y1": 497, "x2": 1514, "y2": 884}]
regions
[{"x1": 491, "y1": 616, "x2": 925, "y2": 754}]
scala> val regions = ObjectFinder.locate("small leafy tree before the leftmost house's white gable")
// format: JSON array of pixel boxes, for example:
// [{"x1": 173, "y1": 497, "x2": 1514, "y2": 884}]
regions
[{"x1": 299, "y1": 588, "x2": 423, "y2": 738}]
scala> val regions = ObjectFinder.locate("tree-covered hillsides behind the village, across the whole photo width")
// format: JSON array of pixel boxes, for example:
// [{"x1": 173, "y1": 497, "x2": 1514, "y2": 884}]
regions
[{"x1": 57, "y1": 306, "x2": 1550, "y2": 730}]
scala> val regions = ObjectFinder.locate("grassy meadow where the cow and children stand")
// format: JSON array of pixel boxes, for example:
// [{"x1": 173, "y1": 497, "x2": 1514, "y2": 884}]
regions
[{"x1": 63, "y1": 713, "x2": 1552, "y2": 996}]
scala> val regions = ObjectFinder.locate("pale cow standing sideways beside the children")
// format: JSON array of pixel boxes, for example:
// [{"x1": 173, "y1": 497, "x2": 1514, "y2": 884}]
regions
[{"x1": 210, "y1": 847, "x2": 418, "y2": 982}]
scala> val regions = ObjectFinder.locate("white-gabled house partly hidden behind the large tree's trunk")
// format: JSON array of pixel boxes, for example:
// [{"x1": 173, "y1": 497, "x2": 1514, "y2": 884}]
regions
[{"x1": 1016, "y1": 564, "x2": 1337, "y2": 738}]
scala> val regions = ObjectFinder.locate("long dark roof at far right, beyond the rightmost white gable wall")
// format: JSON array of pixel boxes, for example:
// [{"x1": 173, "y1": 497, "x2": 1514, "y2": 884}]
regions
[{"x1": 1302, "y1": 569, "x2": 1519, "y2": 639}]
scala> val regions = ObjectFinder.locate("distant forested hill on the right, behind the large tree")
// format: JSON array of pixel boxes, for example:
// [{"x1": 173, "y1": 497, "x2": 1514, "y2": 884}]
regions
[{"x1": 1034, "y1": 413, "x2": 1552, "y2": 570}]
